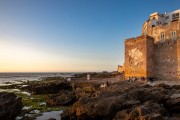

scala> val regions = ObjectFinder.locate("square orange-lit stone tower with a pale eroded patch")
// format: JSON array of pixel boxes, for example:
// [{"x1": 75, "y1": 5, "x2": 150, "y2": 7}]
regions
[{"x1": 125, "y1": 35, "x2": 154, "y2": 77}]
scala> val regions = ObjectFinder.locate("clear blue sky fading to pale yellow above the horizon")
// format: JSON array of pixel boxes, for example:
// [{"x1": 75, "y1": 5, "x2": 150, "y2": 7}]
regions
[{"x1": 0, "y1": 0, "x2": 180, "y2": 72}]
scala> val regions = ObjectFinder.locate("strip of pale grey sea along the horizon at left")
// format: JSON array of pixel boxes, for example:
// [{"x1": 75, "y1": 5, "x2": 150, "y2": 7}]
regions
[{"x1": 0, "y1": 73, "x2": 74, "y2": 84}]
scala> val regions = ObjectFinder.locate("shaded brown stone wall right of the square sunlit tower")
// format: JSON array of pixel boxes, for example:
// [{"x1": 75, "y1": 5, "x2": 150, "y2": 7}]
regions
[{"x1": 154, "y1": 39, "x2": 180, "y2": 79}]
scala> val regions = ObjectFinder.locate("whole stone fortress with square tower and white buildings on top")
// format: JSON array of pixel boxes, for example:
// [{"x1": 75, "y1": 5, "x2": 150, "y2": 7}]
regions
[{"x1": 124, "y1": 10, "x2": 180, "y2": 79}]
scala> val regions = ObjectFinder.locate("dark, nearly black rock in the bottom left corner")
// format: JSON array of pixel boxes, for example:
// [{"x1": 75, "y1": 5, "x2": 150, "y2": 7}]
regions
[{"x1": 0, "y1": 92, "x2": 23, "y2": 120}]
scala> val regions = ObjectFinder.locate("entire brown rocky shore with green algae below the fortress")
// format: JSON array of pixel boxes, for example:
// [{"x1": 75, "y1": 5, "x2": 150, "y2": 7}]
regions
[{"x1": 0, "y1": 73, "x2": 180, "y2": 120}]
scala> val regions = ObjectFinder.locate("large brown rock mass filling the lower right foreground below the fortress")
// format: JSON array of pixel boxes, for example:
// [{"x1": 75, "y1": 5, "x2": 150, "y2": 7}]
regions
[{"x1": 61, "y1": 81, "x2": 180, "y2": 120}]
